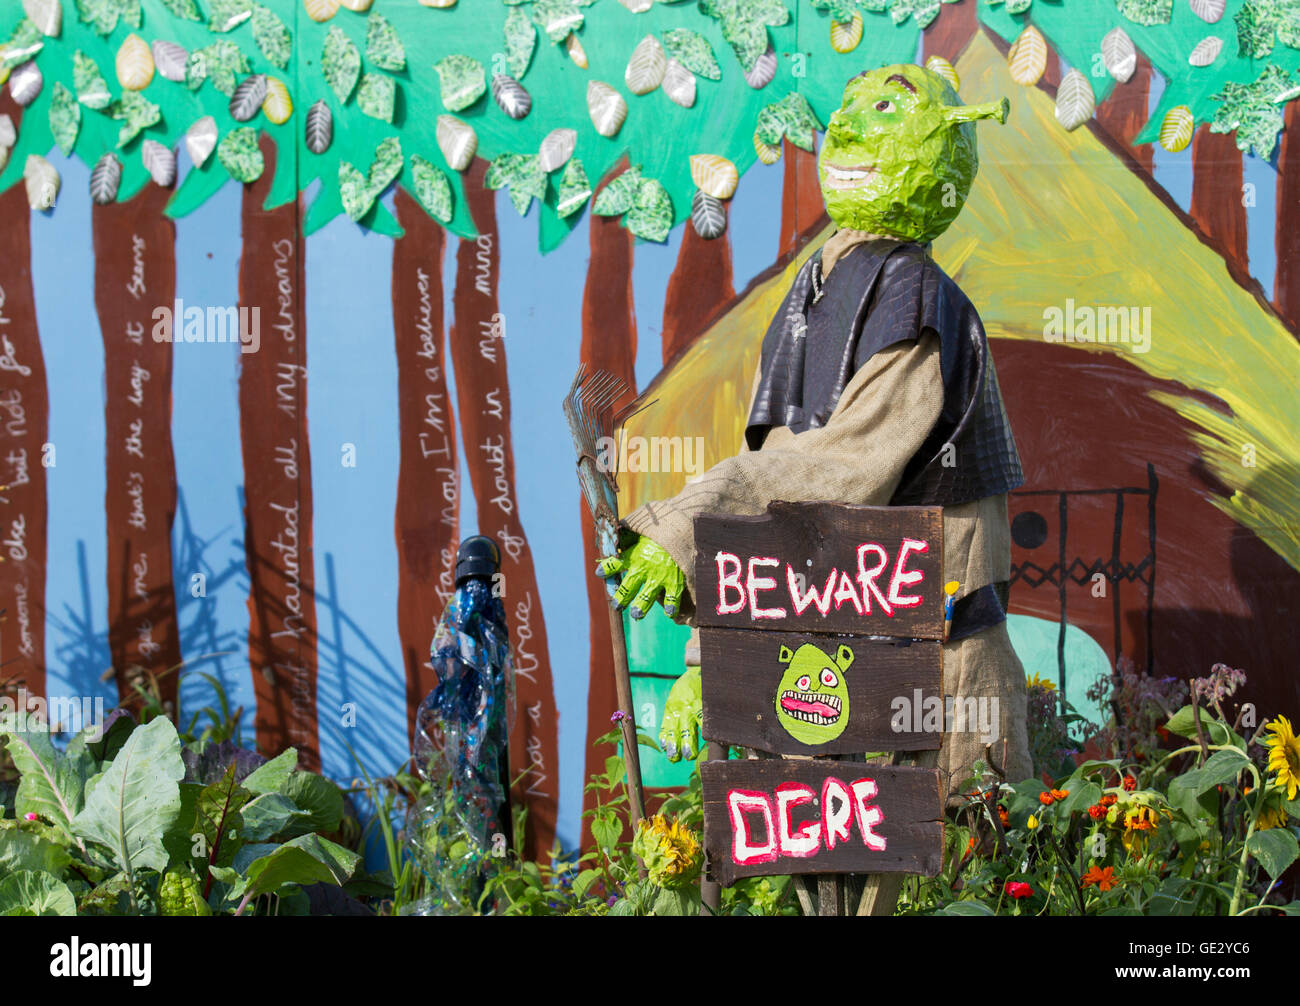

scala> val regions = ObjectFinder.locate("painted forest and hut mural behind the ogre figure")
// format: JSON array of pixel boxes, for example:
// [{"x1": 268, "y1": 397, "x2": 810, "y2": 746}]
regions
[{"x1": 0, "y1": 0, "x2": 1300, "y2": 853}]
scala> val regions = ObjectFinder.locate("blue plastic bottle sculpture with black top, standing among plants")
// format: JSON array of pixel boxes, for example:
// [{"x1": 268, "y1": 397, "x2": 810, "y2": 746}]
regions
[{"x1": 406, "y1": 535, "x2": 515, "y2": 915}]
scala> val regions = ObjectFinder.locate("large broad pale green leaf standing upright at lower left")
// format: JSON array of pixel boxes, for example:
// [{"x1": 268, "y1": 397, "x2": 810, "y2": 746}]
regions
[{"x1": 73, "y1": 716, "x2": 185, "y2": 873}]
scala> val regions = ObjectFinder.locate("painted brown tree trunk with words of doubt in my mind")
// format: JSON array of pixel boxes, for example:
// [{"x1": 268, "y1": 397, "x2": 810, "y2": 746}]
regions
[{"x1": 451, "y1": 159, "x2": 559, "y2": 858}]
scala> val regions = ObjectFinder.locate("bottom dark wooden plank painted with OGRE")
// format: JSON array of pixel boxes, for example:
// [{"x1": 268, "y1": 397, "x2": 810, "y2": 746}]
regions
[{"x1": 701, "y1": 759, "x2": 944, "y2": 885}]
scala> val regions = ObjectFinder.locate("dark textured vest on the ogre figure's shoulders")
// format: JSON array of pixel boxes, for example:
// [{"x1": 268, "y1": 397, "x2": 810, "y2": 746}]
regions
[{"x1": 745, "y1": 240, "x2": 1024, "y2": 507}]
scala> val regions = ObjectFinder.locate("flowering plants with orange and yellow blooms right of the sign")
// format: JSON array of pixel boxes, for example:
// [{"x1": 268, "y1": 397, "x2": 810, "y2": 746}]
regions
[{"x1": 900, "y1": 664, "x2": 1300, "y2": 915}]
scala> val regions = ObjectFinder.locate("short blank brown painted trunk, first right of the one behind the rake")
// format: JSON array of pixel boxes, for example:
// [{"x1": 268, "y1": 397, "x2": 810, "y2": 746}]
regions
[{"x1": 660, "y1": 203, "x2": 736, "y2": 365}]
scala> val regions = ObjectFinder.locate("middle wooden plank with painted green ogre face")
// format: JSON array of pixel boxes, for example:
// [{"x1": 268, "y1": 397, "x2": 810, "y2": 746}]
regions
[{"x1": 699, "y1": 629, "x2": 944, "y2": 755}]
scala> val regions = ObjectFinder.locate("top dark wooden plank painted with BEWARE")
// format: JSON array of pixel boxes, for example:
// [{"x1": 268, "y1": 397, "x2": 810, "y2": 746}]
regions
[{"x1": 696, "y1": 503, "x2": 944, "y2": 639}]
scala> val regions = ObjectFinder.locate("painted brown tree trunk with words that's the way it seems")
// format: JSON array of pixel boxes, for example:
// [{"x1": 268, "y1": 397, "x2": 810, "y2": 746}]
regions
[{"x1": 91, "y1": 185, "x2": 181, "y2": 715}]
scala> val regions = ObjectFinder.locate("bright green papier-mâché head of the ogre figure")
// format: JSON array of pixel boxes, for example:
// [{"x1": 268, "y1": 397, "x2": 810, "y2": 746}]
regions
[{"x1": 818, "y1": 65, "x2": 1010, "y2": 242}]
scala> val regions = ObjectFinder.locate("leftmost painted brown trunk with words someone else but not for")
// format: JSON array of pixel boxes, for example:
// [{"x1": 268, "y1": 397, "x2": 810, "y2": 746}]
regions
[{"x1": 0, "y1": 92, "x2": 49, "y2": 695}]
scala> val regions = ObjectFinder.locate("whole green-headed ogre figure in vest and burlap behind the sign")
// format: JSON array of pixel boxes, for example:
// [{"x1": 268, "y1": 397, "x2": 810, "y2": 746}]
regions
[{"x1": 598, "y1": 65, "x2": 1031, "y2": 800}]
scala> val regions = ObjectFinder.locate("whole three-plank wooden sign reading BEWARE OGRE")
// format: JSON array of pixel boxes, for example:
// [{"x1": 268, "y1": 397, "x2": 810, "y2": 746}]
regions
[{"x1": 696, "y1": 503, "x2": 944, "y2": 899}]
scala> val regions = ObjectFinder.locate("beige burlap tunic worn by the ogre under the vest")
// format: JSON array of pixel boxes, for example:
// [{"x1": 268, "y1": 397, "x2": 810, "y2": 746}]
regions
[{"x1": 624, "y1": 231, "x2": 1032, "y2": 790}]
